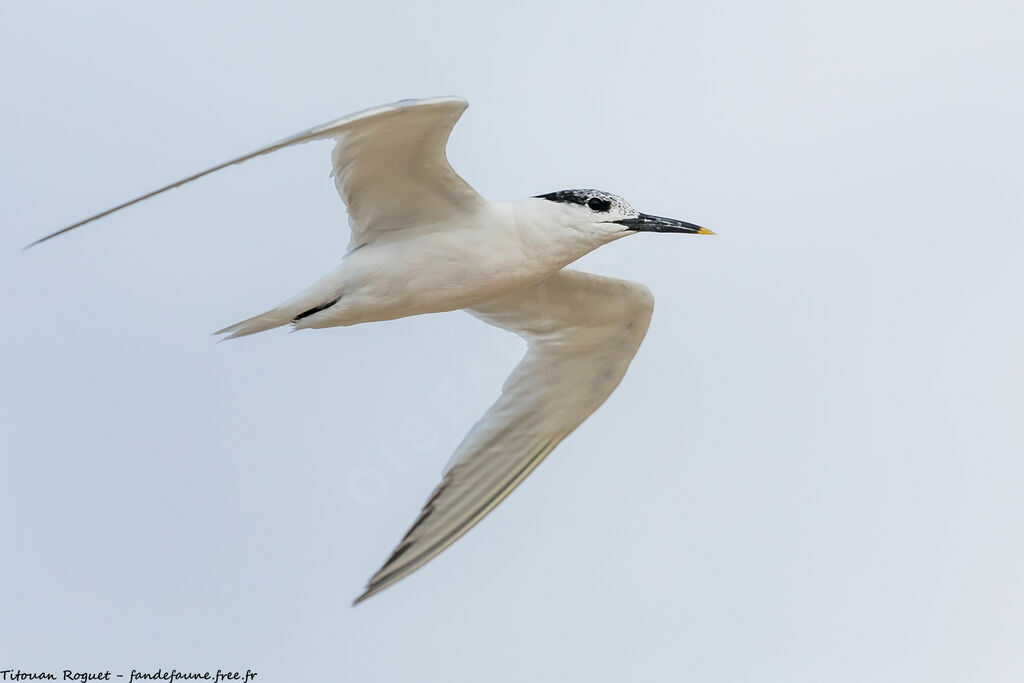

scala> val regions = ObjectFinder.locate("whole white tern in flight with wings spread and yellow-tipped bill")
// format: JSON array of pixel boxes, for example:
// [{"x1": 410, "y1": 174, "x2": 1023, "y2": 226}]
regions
[{"x1": 29, "y1": 97, "x2": 713, "y2": 604}]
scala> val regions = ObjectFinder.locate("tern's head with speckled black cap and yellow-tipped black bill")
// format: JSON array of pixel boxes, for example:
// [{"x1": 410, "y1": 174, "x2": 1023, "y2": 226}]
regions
[{"x1": 537, "y1": 189, "x2": 715, "y2": 240}]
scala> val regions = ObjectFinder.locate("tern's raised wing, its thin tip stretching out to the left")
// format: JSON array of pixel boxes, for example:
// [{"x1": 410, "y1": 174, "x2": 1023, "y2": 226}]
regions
[{"x1": 29, "y1": 97, "x2": 483, "y2": 247}]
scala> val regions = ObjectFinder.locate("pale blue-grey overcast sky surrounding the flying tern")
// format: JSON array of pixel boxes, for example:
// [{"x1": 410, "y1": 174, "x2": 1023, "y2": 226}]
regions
[{"x1": 0, "y1": 0, "x2": 1024, "y2": 683}]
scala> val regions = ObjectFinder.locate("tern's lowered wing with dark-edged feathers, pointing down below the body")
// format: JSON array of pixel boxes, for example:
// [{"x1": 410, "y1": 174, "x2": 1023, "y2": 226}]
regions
[{"x1": 355, "y1": 270, "x2": 653, "y2": 603}]
